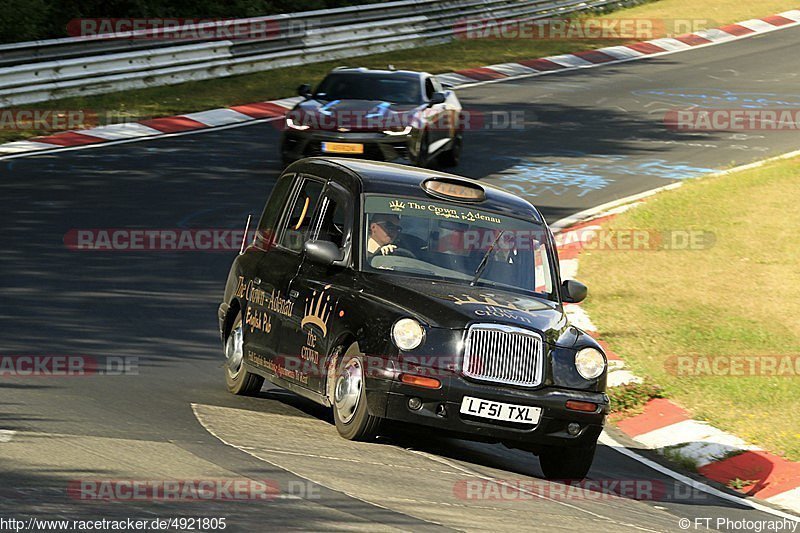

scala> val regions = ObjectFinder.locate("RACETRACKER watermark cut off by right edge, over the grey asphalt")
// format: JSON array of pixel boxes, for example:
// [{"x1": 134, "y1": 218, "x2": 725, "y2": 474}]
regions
[{"x1": 664, "y1": 108, "x2": 800, "y2": 129}]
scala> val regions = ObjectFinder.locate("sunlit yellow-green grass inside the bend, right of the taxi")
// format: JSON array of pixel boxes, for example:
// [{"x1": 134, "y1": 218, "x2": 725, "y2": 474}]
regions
[{"x1": 580, "y1": 159, "x2": 800, "y2": 460}]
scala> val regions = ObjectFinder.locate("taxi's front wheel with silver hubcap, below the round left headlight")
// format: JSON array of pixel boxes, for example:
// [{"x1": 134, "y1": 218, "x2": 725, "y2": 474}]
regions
[{"x1": 331, "y1": 344, "x2": 381, "y2": 441}]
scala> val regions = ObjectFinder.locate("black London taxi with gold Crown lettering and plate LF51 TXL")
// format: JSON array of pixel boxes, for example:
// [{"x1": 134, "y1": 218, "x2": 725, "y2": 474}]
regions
[{"x1": 218, "y1": 158, "x2": 609, "y2": 479}]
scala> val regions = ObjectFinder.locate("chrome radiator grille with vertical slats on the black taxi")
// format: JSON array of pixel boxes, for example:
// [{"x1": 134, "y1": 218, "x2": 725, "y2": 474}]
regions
[{"x1": 462, "y1": 324, "x2": 544, "y2": 387}]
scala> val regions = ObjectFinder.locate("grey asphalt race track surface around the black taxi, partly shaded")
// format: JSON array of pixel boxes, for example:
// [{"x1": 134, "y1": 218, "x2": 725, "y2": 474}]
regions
[{"x1": 0, "y1": 22, "x2": 800, "y2": 532}]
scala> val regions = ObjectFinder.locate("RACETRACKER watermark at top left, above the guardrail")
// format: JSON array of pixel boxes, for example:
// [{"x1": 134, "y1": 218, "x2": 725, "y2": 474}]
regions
[{"x1": 67, "y1": 17, "x2": 312, "y2": 41}]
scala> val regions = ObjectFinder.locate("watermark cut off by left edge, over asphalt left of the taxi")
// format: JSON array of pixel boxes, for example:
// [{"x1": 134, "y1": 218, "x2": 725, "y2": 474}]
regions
[{"x1": 0, "y1": 355, "x2": 139, "y2": 377}]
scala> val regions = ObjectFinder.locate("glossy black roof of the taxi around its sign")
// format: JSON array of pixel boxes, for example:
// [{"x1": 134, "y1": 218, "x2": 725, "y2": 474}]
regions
[{"x1": 305, "y1": 157, "x2": 544, "y2": 224}]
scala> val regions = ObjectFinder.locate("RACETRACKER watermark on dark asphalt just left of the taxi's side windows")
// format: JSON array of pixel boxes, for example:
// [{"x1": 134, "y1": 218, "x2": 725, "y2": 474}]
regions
[{"x1": 64, "y1": 228, "x2": 270, "y2": 252}]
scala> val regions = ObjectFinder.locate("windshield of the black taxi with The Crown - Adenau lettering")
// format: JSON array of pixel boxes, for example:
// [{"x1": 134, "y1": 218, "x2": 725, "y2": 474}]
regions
[{"x1": 362, "y1": 195, "x2": 555, "y2": 299}]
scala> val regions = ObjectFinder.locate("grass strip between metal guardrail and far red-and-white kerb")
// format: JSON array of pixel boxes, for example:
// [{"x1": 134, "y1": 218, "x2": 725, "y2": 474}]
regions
[{"x1": 0, "y1": 0, "x2": 797, "y2": 142}]
